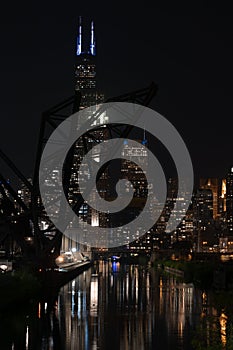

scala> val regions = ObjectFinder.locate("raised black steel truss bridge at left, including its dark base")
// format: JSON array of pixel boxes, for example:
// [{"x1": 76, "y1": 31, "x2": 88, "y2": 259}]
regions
[{"x1": 0, "y1": 82, "x2": 157, "y2": 267}]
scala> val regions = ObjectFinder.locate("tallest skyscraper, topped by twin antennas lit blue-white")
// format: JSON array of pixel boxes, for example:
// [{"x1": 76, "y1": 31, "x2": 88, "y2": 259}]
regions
[{"x1": 69, "y1": 17, "x2": 105, "y2": 208}]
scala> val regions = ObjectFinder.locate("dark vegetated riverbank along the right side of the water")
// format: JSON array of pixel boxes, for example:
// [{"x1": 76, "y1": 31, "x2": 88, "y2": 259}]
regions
[{"x1": 153, "y1": 260, "x2": 233, "y2": 350}]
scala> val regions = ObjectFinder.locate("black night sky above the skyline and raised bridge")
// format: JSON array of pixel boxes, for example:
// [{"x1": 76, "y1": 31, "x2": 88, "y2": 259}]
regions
[{"x1": 0, "y1": 1, "x2": 233, "y2": 183}]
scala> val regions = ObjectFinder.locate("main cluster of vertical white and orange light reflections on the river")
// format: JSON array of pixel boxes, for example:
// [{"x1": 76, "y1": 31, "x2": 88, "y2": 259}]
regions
[{"x1": 43, "y1": 261, "x2": 197, "y2": 350}]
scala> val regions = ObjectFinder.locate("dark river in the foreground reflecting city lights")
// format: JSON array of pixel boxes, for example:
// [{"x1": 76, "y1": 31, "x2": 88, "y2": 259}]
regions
[{"x1": 0, "y1": 262, "x2": 228, "y2": 350}]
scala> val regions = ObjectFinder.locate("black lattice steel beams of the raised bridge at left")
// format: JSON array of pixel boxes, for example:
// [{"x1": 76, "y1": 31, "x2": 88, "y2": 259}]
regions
[{"x1": 0, "y1": 83, "x2": 157, "y2": 268}]
